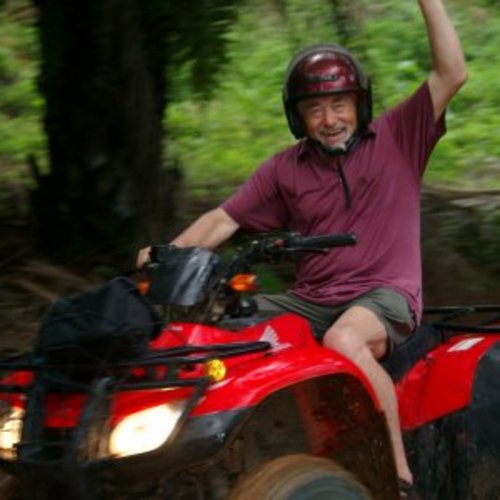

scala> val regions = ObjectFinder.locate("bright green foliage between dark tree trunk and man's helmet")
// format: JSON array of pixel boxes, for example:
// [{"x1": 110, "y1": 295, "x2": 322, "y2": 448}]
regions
[{"x1": 167, "y1": 0, "x2": 338, "y2": 195}]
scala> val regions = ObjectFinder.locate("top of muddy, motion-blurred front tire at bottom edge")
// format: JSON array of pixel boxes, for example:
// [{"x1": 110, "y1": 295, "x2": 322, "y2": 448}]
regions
[{"x1": 229, "y1": 454, "x2": 372, "y2": 500}]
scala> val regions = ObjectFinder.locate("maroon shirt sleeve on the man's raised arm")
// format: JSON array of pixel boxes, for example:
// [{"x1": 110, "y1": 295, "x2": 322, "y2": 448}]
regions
[{"x1": 387, "y1": 82, "x2": 446, "y2": 176}]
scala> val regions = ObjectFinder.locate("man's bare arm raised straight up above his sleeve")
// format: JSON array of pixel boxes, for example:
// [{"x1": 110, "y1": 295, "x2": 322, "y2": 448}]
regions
[{"x1": 418, "y1": 0, "x2": 467, "y2": 120}]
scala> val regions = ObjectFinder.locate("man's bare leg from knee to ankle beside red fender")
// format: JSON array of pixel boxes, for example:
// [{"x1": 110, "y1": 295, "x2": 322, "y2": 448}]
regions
[{"x1": 323, "y1": 306, "x2": 413, "y2": 483}]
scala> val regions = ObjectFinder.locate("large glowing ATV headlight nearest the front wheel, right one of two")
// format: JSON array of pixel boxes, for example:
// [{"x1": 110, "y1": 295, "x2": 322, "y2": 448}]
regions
[{"x1": 109, "y1": 404, "x2": 184, "y2": 457}]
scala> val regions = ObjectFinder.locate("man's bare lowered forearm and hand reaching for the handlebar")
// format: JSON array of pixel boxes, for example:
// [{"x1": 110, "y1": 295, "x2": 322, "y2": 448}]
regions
[{"x1": 137, "y1": 207, "x2": 239, "y2": 268}]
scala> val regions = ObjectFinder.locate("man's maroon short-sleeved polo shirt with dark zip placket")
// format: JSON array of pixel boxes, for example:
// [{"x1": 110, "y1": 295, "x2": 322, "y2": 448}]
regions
[{"x1": 222, "y1": 83, "x2": 445, "y2": 321}]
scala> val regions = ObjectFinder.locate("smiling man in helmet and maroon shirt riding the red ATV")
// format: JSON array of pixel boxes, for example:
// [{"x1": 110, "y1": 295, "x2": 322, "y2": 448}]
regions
[{"x1": 138, "y1": 0, "x2": 467, "y2": 498}]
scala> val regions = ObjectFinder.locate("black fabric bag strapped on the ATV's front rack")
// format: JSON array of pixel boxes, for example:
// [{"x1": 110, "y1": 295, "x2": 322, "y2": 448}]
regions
[{"x1": 35, "y1": 277, "x2": 163, "y2": 372}]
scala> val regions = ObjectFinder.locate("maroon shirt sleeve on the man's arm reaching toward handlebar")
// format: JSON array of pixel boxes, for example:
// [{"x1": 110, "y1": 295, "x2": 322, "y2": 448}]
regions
[{"x1": 221, "y1": 157, "x2": 288, "y2": 231}]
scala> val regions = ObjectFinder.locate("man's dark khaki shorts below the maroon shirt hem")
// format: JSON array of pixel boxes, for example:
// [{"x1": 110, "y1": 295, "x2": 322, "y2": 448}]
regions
[{"x1": 255, "y1": 288, "x2": 415, "y2": 345}]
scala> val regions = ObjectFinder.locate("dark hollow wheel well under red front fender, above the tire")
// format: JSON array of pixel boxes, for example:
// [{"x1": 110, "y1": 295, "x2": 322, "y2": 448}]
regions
[{"x1": 221, "y1": 373, "x2": 397, "y2": 499}]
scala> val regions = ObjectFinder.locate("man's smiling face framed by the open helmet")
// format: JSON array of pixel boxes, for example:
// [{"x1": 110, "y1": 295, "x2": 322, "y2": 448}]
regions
[{"x1": 298, "y1": 93, "x2": 358, "y2": 149}]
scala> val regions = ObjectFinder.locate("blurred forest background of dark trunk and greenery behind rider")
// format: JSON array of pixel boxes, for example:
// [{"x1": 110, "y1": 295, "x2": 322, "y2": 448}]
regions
[{"x1": 0, "y1": 0, "x2": 500, "y2": 348}]
